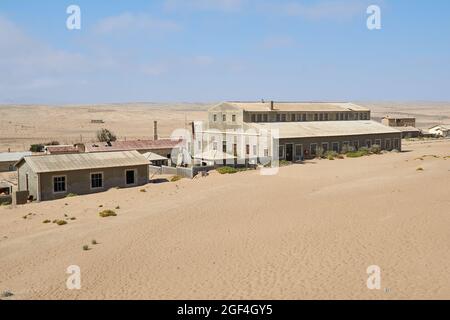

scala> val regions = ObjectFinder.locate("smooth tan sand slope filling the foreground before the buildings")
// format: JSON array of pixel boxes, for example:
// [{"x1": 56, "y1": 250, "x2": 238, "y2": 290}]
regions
[{"x1": 0, "y1": 141, "x2": 450, "y2": 299}]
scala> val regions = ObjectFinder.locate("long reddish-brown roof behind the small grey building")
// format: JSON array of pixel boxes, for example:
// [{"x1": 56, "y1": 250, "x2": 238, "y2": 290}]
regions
[{"x1": 85, "y1": 139, "x2": 183, "y2": 152}]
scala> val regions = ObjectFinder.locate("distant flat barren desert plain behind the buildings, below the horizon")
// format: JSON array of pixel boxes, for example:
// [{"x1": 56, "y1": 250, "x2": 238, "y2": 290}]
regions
[{"x1": 0, "y1": 102, "x2": 450, "y2": 152}]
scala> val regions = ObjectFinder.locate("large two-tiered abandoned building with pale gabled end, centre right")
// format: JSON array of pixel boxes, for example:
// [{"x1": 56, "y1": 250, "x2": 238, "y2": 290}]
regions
[{"x1": 193, "y1": 101, "x2": 402, "y2": 163}]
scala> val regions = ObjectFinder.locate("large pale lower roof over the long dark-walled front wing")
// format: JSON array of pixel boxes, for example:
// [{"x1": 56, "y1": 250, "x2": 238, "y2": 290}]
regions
[{"x1": 251, "y1": 120, "x2": 400, "y2": 138}]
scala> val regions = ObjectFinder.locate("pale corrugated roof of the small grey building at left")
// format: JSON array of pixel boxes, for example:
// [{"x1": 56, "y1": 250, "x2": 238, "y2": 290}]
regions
[{"x1": 19, "y1": 151, "x2": 148, "y2": 173}]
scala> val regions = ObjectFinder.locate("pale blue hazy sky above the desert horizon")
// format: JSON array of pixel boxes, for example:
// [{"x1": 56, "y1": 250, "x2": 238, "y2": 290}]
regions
[{"x1": 0, "y1": 0, "x2": 450, "y2": 104}]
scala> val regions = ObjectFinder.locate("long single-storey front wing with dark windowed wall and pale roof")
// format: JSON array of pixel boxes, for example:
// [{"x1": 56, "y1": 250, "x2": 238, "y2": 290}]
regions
[{"x1": 251, "y1": 120, "x2": 402, "y2": 161}]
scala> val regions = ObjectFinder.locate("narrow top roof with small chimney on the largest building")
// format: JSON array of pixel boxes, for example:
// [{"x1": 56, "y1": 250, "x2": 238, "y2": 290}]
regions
[{"x1": 221, "y1": 101, "x2": 370, "y2": 112}]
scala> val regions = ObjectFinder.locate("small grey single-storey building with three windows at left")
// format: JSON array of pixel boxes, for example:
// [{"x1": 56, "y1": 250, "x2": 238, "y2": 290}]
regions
[{"x1": 16, "y1": 151, "x2": 149, "y2": 201}]
